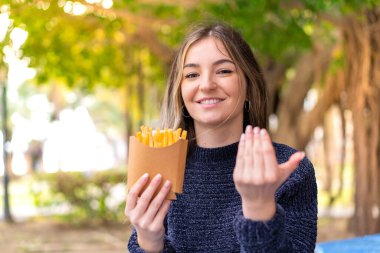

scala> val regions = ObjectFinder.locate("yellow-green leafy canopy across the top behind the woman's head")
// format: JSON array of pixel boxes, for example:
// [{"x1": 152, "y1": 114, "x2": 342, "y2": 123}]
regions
[{"x1": 0, "y1": 0, "x2": 380, "y2": 134}]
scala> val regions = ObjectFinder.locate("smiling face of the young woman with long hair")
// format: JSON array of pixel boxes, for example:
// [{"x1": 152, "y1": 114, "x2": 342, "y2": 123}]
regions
[{"x1": 181, "y1": 37, "x2": 247, "y2": 129}]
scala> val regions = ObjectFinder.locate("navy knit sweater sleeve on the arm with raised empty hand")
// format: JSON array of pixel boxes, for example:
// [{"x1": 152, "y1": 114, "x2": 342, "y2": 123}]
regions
[{"x1": 234, "y1": 159, "x2": 318, "y2": 253}]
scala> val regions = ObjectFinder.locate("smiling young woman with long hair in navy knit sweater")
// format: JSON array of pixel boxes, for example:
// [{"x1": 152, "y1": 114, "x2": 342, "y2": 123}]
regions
[{"x1": 125, "y1": 24, "x2": 317, "y2": 253}]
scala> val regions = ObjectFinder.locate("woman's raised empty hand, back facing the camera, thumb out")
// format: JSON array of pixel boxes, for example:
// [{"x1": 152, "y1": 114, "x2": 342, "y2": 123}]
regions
[{"x1": 233, "y1": 126, "x2": 305, "y2": 221}]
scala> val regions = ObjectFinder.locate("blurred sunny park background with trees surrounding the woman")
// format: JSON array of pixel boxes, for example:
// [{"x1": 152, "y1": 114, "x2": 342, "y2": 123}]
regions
[{"x1": 0, "y1": 0, "x2": 380, "y2": 252}]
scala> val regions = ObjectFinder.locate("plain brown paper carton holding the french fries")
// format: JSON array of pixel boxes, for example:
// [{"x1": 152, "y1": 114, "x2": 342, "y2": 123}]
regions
[{"x1": 127, "y1": 136, "x2": 188, "y2": 200}]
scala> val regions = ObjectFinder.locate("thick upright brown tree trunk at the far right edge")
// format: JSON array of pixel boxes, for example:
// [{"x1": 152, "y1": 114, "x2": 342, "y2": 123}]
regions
[{"x1": 343, "y1": 11, "x2": 380, "y2": 235}]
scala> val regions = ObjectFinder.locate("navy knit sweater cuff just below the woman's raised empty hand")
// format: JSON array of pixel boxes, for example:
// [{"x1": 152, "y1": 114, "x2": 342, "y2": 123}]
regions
[{"x1": 234, "y1": 204, "x2": 285, "y2": 249}]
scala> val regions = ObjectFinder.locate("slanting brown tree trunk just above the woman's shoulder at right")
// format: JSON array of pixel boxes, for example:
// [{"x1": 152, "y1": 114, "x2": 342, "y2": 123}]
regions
[{"x1": 273, "y1": 48, "x2": 334, "y2": 150}]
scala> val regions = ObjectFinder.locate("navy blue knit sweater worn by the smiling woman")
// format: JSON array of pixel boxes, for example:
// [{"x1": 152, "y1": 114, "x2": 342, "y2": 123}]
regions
[{"x1": 128, "y1": 143, "x2": 317, "y2": 253}]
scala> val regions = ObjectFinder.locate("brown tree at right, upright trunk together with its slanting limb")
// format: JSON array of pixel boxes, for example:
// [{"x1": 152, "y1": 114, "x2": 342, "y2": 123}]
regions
[{"x1": 274, "y1": 6, "x2": 380, "y2": 235}]
